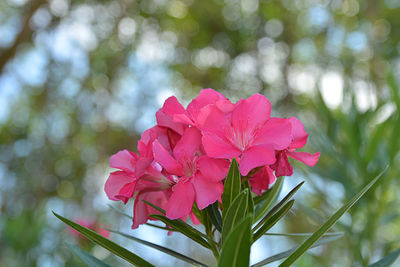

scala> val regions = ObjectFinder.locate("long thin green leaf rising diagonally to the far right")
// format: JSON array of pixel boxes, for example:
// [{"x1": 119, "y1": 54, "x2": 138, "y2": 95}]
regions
[{"x1": 279, "y1": 170, "x2": 387, "y2": 266}]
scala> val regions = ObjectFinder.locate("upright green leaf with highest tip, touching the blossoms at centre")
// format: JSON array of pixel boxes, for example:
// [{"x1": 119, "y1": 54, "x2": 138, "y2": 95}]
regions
[{"x1": 222, "y1": 159, "x2": 241, "y2": 218}]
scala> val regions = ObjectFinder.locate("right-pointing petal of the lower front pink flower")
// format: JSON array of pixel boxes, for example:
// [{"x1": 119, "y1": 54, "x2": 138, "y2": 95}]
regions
[{"x1": 197, "y1": 156, "x2": 229, "y2": 182}]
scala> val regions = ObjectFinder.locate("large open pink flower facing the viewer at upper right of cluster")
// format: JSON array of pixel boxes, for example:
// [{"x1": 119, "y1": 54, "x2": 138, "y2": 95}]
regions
[{"x1": 198, "y1": 94, "x2": 291, "y2": 176}]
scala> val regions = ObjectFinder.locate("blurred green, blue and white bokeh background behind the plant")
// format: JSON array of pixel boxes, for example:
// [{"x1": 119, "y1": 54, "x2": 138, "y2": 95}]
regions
[{"x1": 0, "y1": 0, "x2": 400, "y2": 266}]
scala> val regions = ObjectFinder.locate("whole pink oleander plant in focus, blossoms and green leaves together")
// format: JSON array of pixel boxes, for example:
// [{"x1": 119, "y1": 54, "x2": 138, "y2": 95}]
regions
[{"x1": 56, "y1": 89, "x2": 386, "y2": 266}]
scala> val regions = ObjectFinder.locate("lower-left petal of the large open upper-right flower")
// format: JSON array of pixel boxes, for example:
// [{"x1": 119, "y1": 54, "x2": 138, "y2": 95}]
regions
[{"x1": 202, "y1": 132, "x2": 241, "y2": 159}]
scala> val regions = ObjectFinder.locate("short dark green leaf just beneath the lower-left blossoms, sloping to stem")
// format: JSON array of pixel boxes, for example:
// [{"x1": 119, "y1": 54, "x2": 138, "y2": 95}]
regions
[{"x1": 149, "y1": 214, "x2": 211, "y2": 249}]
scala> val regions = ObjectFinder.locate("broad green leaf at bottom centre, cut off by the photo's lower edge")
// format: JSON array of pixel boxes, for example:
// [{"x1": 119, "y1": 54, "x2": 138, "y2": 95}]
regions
[{"x1": 218, "y1": 216, "x2": 253, "y2": 267}]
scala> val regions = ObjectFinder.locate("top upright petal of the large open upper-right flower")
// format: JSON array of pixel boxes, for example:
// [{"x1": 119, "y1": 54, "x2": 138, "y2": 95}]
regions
[{"x1": 232, "y1": 94, "x2": 271, "y2": 136}]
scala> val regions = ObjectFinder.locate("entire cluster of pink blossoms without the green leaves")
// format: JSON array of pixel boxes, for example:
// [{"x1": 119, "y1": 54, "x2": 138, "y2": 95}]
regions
[{"x1": 105, "y1": 89, "x2": 319, "y2": 228}]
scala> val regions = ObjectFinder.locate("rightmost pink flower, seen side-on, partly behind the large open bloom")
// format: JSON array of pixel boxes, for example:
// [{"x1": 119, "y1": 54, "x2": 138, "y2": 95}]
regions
[{"x1": 271, "y1": 117, "x2": 320, "y2": 177}]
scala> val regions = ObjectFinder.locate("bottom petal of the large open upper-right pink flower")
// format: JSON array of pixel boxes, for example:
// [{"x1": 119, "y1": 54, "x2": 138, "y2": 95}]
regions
[{"x1": 239, "y1": 145, "x2": 276, "y2": 176}]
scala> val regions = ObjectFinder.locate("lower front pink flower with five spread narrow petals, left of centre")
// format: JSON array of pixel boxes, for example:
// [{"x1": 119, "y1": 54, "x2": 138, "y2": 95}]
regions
[{"x1": 153, "y1": 127, "x2": 229, "y2": 219}]
